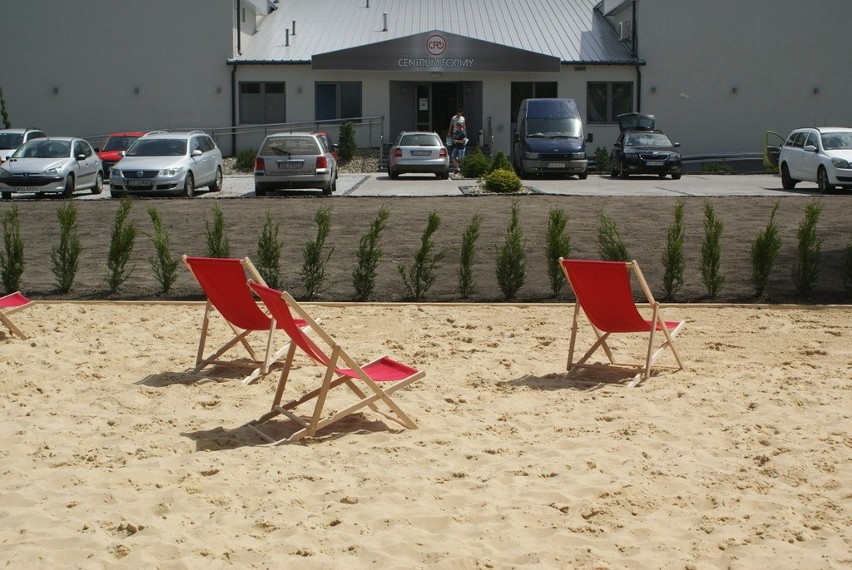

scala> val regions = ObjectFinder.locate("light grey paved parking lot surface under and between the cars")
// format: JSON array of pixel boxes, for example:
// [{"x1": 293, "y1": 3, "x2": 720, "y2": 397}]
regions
[{"x1": 0, "y1": 172, "x2": 848, "y2": 200}]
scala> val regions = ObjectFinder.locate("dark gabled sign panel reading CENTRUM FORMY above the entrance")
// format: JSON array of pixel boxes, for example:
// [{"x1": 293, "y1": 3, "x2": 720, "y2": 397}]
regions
[{"x1": 311, "y1": 30, "x2": 560, "y2": 73}]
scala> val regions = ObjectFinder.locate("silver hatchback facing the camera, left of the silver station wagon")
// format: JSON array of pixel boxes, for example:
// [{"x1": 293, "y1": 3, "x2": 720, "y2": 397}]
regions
[{"x1": 0, "y1": 137, "x2": 104, "y2": 200}]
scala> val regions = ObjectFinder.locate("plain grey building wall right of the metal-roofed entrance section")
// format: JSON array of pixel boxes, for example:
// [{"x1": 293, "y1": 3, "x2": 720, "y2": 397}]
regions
[{"x1": 636, "y1": 0, "x2": 852, "y2": 155}]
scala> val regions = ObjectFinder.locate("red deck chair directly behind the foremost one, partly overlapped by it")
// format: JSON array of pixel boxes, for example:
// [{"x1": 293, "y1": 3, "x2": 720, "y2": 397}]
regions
[{"x1": 183, "y1": 255, "x2": 304, "y2": 384}]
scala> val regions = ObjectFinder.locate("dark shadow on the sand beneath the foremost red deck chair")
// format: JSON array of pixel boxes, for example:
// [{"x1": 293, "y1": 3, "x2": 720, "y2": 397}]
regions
[{"x1": 181, "y1": 413, "x2": 396, "y2": 451}]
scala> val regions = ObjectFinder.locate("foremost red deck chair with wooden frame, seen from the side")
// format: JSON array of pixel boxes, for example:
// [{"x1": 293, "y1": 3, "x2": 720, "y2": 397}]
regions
[{"x1": 246, "y1": 281, "x2": 425, "y2": 445}]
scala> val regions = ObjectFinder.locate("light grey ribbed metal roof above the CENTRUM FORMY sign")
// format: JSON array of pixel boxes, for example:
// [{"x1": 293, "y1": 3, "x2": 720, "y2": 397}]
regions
[{"x1": 236, "y1": 0, "x2": 636, "y2": 65}]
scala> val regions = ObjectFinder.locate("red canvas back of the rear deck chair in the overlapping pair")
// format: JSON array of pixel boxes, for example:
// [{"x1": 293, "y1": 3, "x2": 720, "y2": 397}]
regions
[{"x1": 186, "y1": 257, "x2": 271, "y2": 331}]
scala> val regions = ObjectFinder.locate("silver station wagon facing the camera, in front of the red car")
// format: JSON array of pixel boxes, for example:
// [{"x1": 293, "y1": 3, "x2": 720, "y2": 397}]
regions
[{"x1": 109, "y1": 131, "x2": 222, "y2": 198}]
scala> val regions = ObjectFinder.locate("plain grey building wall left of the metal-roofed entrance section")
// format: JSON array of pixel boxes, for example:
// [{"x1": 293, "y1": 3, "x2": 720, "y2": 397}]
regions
[{"x1": 0, "y1": 0, "x2": 235, "y2": 143}]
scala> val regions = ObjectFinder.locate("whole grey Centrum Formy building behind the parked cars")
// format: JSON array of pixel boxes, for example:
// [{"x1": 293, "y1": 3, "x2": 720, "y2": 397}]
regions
[{"x1": 0, "y1": 0, "x2": 852, "y2": 161}]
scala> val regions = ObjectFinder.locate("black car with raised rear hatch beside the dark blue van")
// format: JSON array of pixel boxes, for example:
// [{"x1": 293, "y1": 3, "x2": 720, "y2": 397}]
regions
[{"x1": 609, "y1": 113, "x2": 683, "y2": 180}]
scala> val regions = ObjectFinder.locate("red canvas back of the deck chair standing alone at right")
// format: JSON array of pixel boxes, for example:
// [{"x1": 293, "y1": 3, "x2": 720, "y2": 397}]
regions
[{"x1": 562, "y1": 259, "x2": 651, "y2": 333}]
